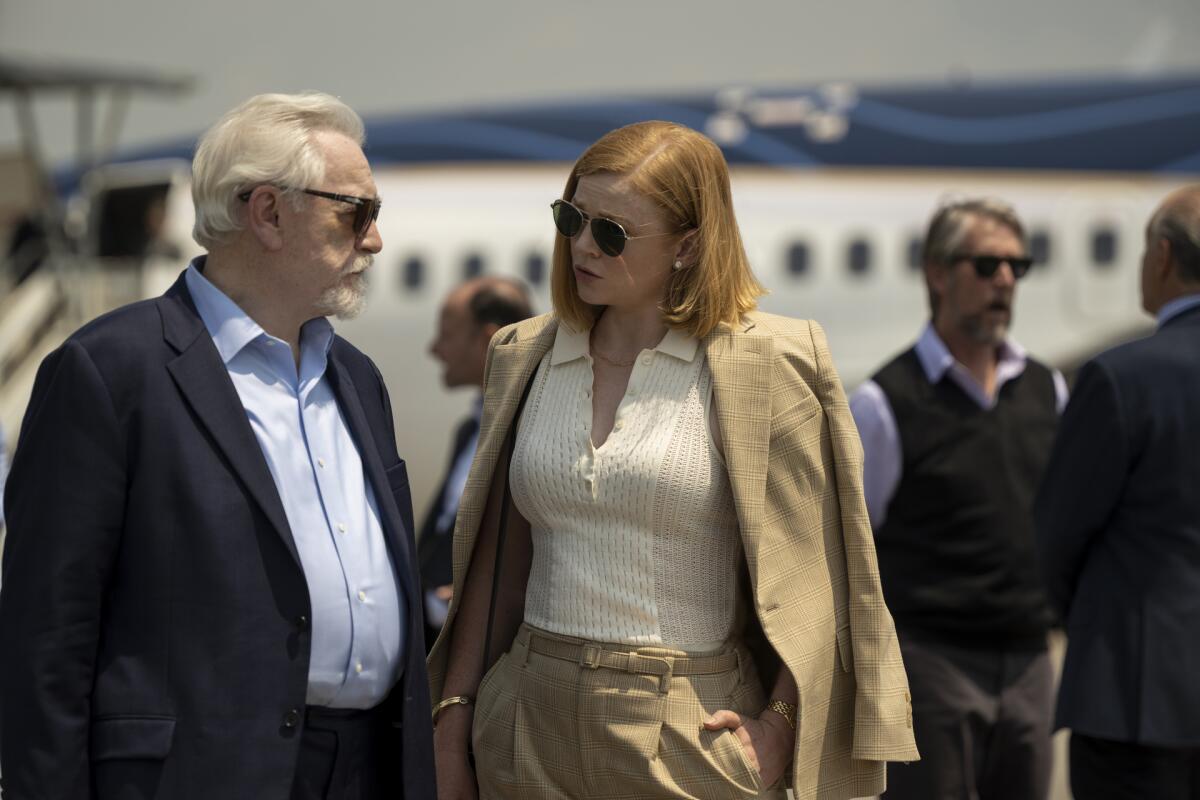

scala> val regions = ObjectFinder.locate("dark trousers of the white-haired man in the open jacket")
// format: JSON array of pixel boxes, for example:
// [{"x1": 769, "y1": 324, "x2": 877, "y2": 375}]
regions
[{"x1": 292, "y1": 705, "x2": 403, "y2": 800}]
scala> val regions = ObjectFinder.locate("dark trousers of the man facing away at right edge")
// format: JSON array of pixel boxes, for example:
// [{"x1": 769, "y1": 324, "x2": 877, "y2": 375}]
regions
[{"x1": 1070, "y1": 732, "x2": 1200, "y2": 800}]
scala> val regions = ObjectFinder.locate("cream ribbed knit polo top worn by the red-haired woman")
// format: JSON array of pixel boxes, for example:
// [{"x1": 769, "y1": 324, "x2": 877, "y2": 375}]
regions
[{"x1": 511, "y1": 325, "x2": 742, "y2": 652}]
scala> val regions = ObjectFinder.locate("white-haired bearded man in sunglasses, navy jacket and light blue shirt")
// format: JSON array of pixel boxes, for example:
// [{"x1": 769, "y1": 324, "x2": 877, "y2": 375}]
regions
[{"x1": 0, "y1": 94, "x2": 434, "y2": 800}]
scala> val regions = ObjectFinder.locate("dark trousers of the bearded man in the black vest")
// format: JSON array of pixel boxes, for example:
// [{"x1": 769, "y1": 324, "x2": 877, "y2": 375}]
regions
[{"x1": 883, "y1": 633, "x2": 1054, "y2": 800}]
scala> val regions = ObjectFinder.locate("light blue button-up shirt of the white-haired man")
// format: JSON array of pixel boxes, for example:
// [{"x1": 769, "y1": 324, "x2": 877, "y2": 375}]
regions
[{"x1": 185, "y1": 257, "x2": 406, "y2": 709}]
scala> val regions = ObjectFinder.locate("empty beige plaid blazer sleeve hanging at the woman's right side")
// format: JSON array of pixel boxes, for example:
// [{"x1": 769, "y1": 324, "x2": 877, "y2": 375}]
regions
[{"x1": 810, "y1": 323, "x2": 919, "y2": 762}]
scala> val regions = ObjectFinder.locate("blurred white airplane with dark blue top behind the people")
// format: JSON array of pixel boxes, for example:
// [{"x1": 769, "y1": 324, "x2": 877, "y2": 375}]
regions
[{"x1": 9, "y1": 76, "x2": 1200, "y2": 512}]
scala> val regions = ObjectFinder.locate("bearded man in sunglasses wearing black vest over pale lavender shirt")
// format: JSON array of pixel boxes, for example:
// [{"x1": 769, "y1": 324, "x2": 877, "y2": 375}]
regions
[{"x1": 850, "y1": 200, "x2": 1067, "y2": 800}]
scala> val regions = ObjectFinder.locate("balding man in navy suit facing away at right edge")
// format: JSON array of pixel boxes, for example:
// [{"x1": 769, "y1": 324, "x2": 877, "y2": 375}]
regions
[{"x1": 1036, "y1": 186, "x2": 1200, "y2": 800}]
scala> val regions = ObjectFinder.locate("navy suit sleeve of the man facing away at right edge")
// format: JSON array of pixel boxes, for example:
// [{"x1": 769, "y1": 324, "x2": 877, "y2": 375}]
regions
[{"x1": 1033, "y1": 361, "x2": 1129, "y2": 619}]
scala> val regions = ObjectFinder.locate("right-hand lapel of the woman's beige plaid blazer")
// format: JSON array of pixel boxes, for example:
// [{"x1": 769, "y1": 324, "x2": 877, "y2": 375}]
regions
[{"x1": 704, "y1": 325, "x2": 774, "y2": 572}]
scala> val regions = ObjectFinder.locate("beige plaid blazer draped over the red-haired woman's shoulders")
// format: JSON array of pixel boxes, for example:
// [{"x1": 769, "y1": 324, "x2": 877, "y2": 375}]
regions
[{"x1": 430, "y1": 312, "x2": 918, "y2": 800}]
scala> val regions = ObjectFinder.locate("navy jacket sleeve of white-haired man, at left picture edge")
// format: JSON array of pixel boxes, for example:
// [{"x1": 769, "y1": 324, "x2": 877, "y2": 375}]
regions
[{"x1": 0, "y1": 341, "x2": 126, "y2": 800}]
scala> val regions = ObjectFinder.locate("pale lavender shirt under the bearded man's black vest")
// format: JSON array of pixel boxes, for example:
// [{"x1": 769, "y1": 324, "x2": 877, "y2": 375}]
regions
[{"x1": 850, "y1": 325, "x2": 1067, "y2": 529}]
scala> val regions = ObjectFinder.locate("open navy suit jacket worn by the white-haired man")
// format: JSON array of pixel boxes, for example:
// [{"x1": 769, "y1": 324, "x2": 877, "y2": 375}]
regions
[{"x1": 0, "y1": 277, "x2": 434, "y2": 800}]
